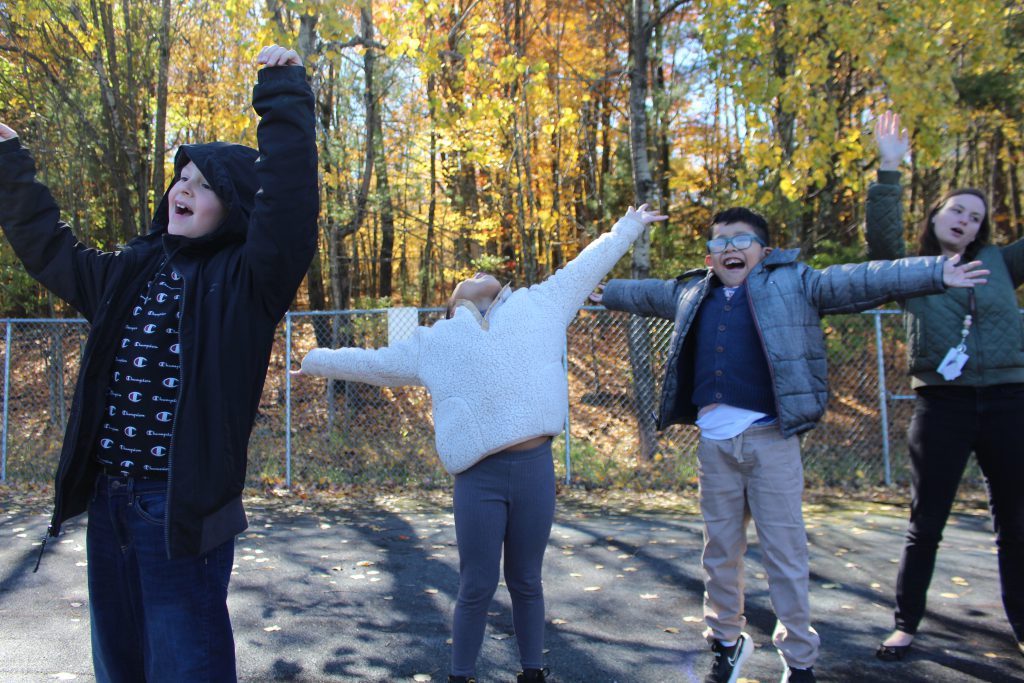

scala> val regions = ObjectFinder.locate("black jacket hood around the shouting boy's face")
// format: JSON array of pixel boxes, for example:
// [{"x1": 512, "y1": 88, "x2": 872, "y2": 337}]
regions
[{"x1": 150, "y1": 142, "x2": 259, "y2": 246}]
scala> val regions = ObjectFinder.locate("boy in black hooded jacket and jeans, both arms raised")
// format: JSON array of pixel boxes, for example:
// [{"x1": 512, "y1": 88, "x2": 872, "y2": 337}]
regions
[{"x1": 0, "y1": 46, "x2": 318, "y2": 682}]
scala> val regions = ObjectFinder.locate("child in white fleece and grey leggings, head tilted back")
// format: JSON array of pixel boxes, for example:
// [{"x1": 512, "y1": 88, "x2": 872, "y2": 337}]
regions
[{"x1": 301, "y1": 205, "x2": 666, "y2": 683}]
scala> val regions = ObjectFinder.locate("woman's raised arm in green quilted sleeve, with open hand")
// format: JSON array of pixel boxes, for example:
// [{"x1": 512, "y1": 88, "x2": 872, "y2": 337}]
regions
[{"x1": 865, "y1": 112, "x2": 910, "y2": 259}]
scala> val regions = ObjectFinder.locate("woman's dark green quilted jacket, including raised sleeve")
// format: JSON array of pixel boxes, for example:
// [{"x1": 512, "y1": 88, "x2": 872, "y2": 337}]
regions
[{"x1": 867, "y1": 171, "x2": 1024, "y2": 388}]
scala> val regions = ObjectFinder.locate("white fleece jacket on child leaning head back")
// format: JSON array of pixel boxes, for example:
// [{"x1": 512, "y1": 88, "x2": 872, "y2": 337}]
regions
[{"x1": 302, "y1": 218, "x2": 644, "y2": 474}]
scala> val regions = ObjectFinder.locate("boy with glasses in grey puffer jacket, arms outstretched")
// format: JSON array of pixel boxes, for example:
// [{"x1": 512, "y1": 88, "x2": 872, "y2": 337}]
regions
[{"x1": 591, "y1": 208, "x2": 988, "y2": 683}]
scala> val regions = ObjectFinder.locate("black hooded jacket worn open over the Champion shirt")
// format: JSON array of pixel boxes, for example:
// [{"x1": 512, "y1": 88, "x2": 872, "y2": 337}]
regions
[{"x1": 0, "y1": 67, "x2": 318, "y2": 558}]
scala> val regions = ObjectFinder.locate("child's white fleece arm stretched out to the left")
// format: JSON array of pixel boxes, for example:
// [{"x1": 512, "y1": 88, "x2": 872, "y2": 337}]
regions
[{"x1": 301, "y1": 328, "x2": 429, "y2": 386}]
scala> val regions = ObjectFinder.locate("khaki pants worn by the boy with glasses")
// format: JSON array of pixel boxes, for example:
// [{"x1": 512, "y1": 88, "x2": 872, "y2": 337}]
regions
[{"x1": 697, "y1": 425, "x2": 820, "y2": 669}]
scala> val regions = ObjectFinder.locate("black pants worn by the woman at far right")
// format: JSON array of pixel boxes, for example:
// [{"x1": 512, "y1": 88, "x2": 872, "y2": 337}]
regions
[{"x1": 896, "y1": 384, "x2": 1024, "y2": 641}]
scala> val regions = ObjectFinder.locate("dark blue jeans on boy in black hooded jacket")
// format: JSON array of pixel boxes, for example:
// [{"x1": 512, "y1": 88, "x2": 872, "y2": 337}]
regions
[{"x1": 86, "y1": 474, "x2": 236, "y2": 683}]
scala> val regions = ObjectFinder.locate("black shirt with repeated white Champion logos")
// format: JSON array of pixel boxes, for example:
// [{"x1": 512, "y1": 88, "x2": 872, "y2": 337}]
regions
[{"x1": 94, "y1": 261, "x2": 183, "y2": 478}]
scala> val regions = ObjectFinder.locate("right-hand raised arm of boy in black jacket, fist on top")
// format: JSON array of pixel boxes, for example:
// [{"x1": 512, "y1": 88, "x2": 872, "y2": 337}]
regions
[{"x1": 245, "y1": 46, "x2": 319, "y2": 314}]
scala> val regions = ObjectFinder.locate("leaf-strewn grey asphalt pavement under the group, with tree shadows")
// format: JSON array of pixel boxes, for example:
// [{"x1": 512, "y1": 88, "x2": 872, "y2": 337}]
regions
[{"x1": 0, "y1": 486, "x2": 1024, "y2": 683}]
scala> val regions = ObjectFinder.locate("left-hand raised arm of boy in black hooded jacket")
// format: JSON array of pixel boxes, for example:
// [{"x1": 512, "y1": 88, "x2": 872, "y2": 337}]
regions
[{"x1": 0, "y1": 124, "x2": 118, "y2": 319}]
